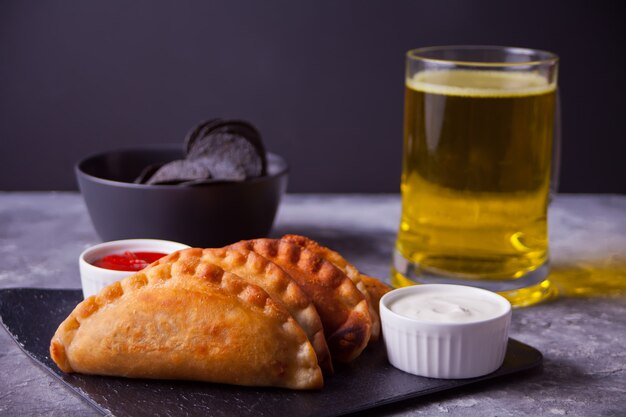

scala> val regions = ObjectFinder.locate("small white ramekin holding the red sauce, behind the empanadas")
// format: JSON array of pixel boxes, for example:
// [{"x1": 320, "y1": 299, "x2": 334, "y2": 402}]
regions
[{"x1": 78, "y1": 239, "x2": 189, "y2": 298}]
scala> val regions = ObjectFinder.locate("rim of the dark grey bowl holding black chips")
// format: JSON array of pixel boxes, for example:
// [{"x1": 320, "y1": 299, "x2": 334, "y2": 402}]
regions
[{"x1": 74, "y1": 144, "x2": 290, "y2": 190}]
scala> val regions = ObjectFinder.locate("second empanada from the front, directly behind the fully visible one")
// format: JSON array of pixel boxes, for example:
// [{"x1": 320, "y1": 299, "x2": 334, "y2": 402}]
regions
[{"x1": 198, "y1": 247, "x2": 333, "y2": 374}]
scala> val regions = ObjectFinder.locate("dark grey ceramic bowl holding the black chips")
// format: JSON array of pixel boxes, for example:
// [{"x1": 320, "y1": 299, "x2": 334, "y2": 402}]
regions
[{"x1": 75, "y1": 146, "x2": 288, "y2": 247}]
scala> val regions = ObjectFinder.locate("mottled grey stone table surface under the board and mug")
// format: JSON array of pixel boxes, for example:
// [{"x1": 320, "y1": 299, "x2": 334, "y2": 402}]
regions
[{"x1": 0, "y1": 192, "x2": 626, "y2": 416}]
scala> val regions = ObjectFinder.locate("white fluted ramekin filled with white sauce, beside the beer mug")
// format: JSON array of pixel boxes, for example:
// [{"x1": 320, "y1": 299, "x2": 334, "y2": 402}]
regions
[{"x1": 380, "y1": 284, "x2": 511, "y2": 379}]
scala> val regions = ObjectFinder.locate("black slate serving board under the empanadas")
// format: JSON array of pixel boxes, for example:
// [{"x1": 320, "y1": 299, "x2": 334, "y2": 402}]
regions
[{"x1": 0, "y1": 288, "x2": 542, "y2": 417}]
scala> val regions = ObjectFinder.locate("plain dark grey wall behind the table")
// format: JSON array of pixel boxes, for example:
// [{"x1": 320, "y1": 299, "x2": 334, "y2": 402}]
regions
[{"x1": 0, "y1": 0, "x2": 626, "y2": 193}]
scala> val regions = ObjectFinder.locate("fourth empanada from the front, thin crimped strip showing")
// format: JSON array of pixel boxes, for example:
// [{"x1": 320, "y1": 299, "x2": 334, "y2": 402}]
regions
[{"x1": 280, "y1": 235, "x2": 380, "y2": 342}]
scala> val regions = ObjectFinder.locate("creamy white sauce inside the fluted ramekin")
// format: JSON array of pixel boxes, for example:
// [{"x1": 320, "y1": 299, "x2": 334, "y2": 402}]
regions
[{"x1": 389, "y1": 290, "x2": 505, "y2": 323}]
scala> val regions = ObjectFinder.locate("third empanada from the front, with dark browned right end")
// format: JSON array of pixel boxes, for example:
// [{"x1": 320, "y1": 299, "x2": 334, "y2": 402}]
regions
[{"x1": 232, "y1": 239, "x2": 372, "y2": 362}]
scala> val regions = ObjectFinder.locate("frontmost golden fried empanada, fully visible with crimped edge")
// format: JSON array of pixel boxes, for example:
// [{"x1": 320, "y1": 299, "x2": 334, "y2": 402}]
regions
[{"x1": 50, "y1": 249, "x2": 323, "y2": 389}]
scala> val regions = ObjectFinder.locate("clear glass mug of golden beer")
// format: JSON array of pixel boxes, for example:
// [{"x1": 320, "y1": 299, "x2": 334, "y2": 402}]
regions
[{"x1": 392, "y1": 46, "x2": 559, "y2": 306}]
